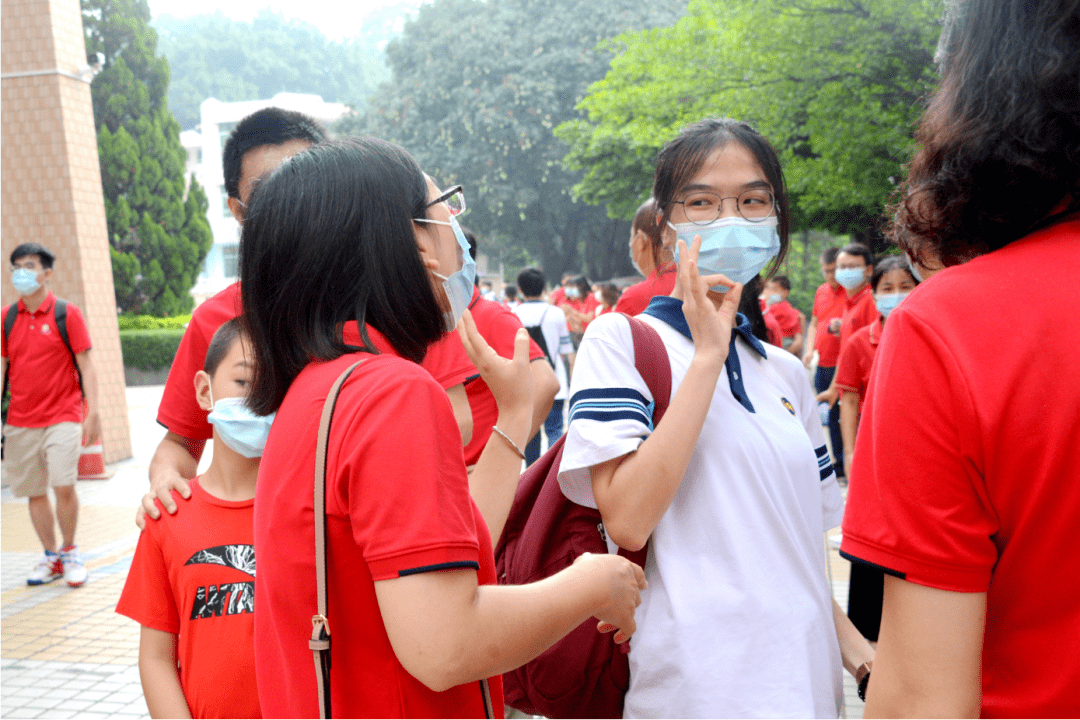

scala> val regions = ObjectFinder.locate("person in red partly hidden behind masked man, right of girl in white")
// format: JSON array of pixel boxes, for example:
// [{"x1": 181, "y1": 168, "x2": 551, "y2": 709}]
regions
[{"x1": 802, "y1": 247, "x2": 848, "y2": 477}]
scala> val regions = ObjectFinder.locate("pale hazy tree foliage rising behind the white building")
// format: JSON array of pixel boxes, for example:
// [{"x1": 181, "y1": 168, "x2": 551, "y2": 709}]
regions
[{"x1": 154, "y1": 10, "x2": 392, "y2": 128}]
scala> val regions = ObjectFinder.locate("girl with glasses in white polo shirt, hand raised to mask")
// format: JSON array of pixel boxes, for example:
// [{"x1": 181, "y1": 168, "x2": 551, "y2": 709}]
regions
[{"x1": 559, "y1": 120, "x2": 873, "y2": 718}]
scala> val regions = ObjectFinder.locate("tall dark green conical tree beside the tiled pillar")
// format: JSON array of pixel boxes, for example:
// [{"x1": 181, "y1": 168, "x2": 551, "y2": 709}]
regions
[{"x1": 82, "y1": 0, "x2": 213, "y2": 316}]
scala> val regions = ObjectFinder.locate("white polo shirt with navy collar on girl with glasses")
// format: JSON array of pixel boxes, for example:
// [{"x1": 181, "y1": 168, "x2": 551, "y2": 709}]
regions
[{"x1": 558, "y1": 297, "x2": 843, "y2": 718}]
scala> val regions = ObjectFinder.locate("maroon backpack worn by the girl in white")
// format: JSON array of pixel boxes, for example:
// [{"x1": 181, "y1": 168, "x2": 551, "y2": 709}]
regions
[{"x1": 495, "y1": 315, "x2": 672, "y2": 718}]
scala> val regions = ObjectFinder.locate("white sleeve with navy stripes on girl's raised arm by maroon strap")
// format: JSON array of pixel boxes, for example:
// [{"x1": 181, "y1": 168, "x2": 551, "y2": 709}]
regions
[{"x1": 558, "y1": 313, "x2": 652, "y2": 507}]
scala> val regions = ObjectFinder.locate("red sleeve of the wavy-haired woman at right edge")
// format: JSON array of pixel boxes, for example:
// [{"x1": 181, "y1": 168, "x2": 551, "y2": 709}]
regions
[{"x1": 841, "y1": 307, "x2": 999, "y2": 593}]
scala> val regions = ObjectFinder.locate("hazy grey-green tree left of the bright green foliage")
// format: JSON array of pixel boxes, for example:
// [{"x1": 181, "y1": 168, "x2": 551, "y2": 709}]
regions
[{"x1": 358, "y1": 0, "x2": 685, "y2": 277}]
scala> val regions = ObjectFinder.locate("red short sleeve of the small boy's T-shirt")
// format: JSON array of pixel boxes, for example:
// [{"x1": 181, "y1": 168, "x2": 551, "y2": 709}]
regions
[{"x1": 117, "y1": 515, "x2": 179, "y2": 635}]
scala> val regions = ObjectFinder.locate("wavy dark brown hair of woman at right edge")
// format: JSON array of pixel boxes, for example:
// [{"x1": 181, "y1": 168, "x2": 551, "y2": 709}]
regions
[{"x1": 890, "y1": 0, "x2": 1080, "y2": 266}]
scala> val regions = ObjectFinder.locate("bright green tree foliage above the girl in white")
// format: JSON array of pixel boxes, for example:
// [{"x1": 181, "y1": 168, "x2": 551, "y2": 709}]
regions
[{"x1": 556, "y1": 0, "x2": 942, "y2": 248}]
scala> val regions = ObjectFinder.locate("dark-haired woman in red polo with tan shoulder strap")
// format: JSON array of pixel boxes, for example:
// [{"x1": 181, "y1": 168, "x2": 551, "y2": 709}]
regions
[{"x1": 241, "y1": 138, "x2": 645, "y2": 717}]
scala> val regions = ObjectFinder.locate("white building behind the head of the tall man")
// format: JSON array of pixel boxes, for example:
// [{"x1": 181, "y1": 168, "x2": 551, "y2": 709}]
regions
[{"x1": 180, "y1": 93, "x2": 349, "y2": 304}]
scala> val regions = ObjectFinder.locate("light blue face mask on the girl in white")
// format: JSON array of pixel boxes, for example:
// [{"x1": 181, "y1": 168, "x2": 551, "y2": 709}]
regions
[{"x1": 667, "y1": 216, "x2": 780, "y2": 293}]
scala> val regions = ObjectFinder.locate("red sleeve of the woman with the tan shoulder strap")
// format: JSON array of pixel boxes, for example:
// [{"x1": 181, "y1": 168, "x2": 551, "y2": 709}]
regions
[{"x1": 327, "y1": 361, "x2": 480, "y2": 581}]
